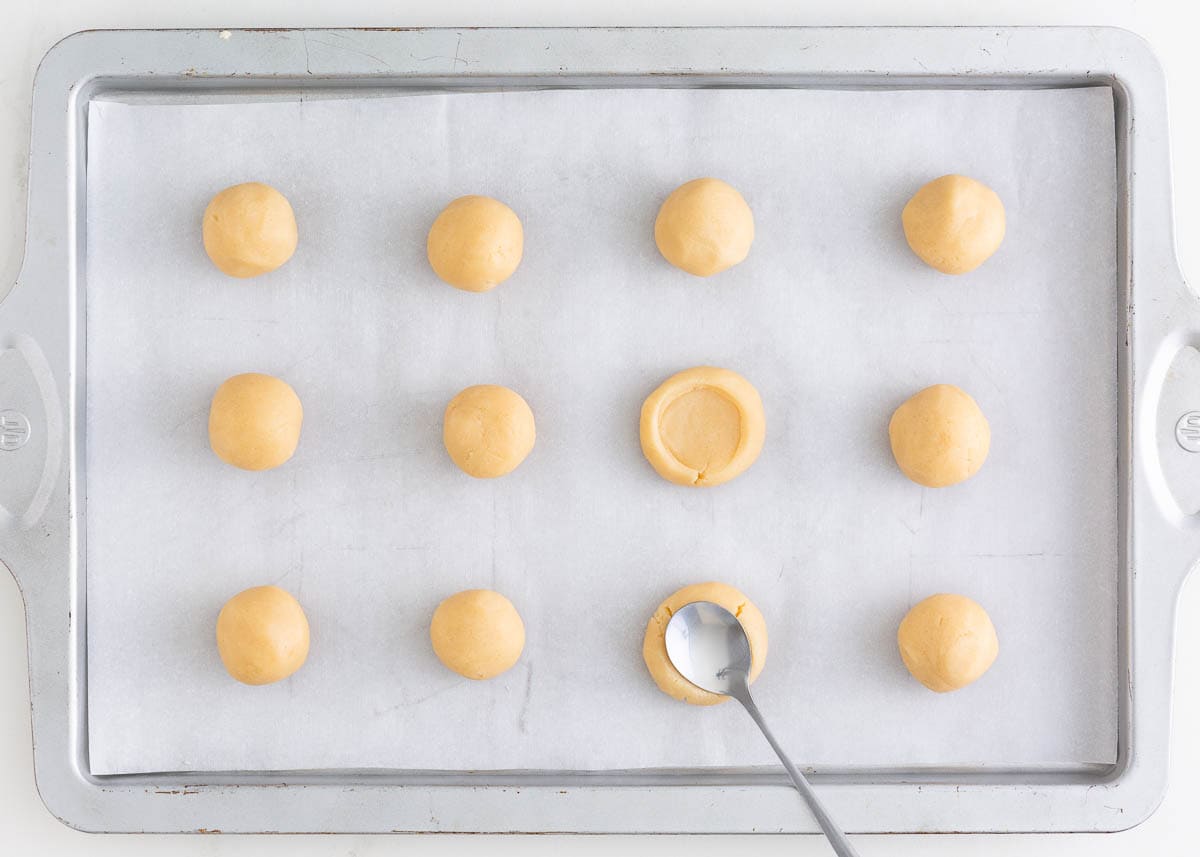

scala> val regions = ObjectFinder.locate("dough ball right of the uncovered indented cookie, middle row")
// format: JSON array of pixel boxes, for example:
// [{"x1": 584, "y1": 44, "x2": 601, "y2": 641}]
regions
[{"x1": 888, "y1": 384, "x2": 991, "y2": 489}]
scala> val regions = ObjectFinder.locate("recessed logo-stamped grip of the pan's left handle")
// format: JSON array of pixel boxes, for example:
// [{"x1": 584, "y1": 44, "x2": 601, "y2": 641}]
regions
[{"x1": 0, "y1": 278, "x2": 66, "y2": 574}]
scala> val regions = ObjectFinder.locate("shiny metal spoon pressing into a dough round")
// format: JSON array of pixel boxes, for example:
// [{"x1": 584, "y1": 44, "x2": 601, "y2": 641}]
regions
[{"x1": 666, "y1": 601, "x2": 858, "y2": 857}]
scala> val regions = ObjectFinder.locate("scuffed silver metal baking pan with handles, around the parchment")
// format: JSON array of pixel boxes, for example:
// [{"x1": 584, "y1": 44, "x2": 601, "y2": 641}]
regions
[{"x1": 0, "y1": 28, "x2": 1200, "y2": 833}]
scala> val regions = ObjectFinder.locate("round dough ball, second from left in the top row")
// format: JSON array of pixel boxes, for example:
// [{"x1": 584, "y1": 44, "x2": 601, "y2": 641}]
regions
[{"x1": 425, "y1": 197, "x2": 524, "y2": 292}]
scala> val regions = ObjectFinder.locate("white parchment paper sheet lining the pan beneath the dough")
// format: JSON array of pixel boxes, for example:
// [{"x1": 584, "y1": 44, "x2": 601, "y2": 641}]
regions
[{"x1": 84, "y1": 88, "x2": 1120, "y2": 774}]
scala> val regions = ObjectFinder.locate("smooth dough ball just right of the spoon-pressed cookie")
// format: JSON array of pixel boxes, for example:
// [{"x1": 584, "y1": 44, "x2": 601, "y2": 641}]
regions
[{"x1": 896, "y1": 594, "x2": 1000, "y2": 694}]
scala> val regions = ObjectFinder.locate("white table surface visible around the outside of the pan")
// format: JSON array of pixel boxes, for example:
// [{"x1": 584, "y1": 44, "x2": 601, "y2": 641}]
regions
[{"x1": 0, "y1": 0, "x2": 1200, "y2": 857}]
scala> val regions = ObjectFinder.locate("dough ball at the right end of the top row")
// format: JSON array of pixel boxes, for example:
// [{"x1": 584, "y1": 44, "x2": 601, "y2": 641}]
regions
[{"x1": 900, "y1": 175, "x2": 1004, "y2": 274}]
